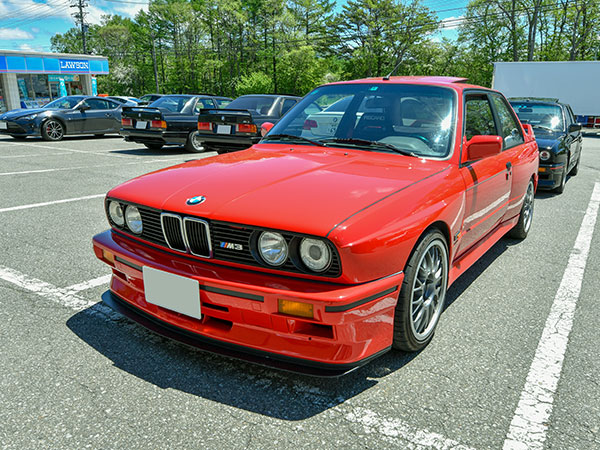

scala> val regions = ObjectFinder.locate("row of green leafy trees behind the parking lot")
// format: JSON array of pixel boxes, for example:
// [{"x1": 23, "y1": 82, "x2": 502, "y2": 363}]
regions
[{"x1": 51, "y1": 0, "x2": 600, "y2": 97}]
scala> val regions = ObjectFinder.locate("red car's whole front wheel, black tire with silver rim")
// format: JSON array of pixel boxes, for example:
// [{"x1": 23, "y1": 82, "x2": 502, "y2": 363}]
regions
[{"x1": 392, "y1": 230, "x2": 449, "y2": 352}]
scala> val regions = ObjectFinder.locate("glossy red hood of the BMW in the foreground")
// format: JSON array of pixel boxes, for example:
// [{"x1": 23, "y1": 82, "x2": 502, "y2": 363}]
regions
[{"x1": 108, "y1": 145, "x2": 448, "y2": 236}]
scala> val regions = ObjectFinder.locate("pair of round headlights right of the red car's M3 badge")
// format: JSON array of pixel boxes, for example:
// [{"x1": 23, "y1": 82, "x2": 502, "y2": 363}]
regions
[{"x1": 257, "y1": 231, "x2": 332, "y2": 273}]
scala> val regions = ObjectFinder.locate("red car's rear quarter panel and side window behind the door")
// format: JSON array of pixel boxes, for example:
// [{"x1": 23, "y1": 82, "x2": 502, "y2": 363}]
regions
[{"x1": 490, "y1": 92, "x2": 535, "y2": 218}]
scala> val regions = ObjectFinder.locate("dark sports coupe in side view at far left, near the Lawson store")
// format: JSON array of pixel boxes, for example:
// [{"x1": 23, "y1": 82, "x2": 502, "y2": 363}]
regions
[{"x1": 0, "y1": 95, "x2": 121, "y2": 141}]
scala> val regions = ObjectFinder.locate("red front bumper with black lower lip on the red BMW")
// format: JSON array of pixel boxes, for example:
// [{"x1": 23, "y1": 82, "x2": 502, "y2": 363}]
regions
[{"x1": 93, "y1": 230, "x2": 404, "y2": 376}]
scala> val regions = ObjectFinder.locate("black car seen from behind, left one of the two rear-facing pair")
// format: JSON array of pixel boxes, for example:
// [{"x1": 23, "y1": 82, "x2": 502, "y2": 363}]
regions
[{"x1": 120, "y1": 94, "x2": 231, "y2": 152}]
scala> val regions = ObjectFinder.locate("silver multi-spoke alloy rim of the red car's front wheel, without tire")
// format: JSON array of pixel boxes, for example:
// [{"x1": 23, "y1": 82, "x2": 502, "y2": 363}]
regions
[{"x1": 410, "y1": 239, "x2": 448, "y2": 341}]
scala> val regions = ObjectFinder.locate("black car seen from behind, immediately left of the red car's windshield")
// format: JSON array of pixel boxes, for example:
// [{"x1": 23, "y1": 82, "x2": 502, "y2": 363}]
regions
[{"x1": 198, "y1": 94, "x2": 301, "y2": 153}]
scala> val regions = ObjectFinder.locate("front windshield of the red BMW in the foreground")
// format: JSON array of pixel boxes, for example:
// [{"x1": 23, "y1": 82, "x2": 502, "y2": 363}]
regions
[{"x1": 264, "y1": 83, "x2": 456, "y2": 158}]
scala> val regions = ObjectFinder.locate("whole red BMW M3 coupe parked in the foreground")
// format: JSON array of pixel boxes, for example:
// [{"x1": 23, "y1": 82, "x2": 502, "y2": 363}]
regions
[{"x1": 93, "y1": 77, "x2": 538, "y2": 375}]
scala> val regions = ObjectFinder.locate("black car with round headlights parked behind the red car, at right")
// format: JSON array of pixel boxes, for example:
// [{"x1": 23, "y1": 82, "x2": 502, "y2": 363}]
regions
[{"x1": 510, "y1": 98, "x2": 583, "y2": 194}]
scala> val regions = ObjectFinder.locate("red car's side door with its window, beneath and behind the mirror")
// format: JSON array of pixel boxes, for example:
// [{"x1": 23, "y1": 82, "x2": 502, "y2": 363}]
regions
[{"x1": 457, "y1": 91, "x2": 512, "y2": 255}]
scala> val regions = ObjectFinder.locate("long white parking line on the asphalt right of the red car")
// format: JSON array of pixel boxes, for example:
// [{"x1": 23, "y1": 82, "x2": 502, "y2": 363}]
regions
[{"x1": 504, "y1": 182, "x2": 600, "y2": 450}]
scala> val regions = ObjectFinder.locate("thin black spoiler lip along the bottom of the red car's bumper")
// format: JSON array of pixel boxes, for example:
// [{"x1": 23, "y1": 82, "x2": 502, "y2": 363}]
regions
[{"x1": 102, "y1": 291, "x2": 391, "y2": 377}]
